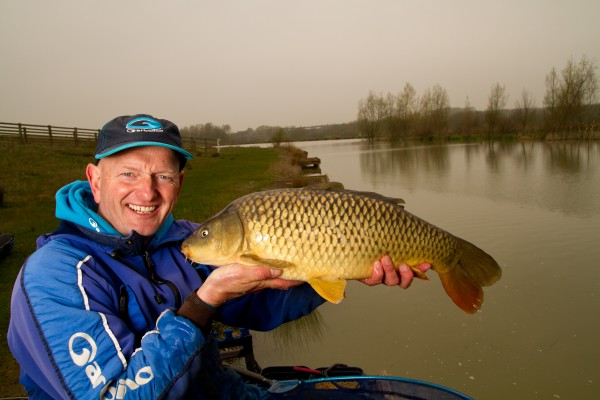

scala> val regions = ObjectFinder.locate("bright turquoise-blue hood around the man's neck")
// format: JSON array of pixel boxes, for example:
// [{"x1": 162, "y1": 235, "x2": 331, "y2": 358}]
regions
[{"x1": 56, "y1": 181, "x2": 173, "y2": 243}]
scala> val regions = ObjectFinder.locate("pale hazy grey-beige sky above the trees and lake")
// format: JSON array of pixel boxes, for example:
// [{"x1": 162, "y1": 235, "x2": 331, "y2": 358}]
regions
[{"x1": 0, "y1": 0, "x2": 600, "y2": 131}]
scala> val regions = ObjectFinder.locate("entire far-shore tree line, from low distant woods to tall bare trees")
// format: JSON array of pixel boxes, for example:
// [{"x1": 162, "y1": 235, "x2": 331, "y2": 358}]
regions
[{"x1": 181, "y1": 56, "x2": 600, "y2": 145}]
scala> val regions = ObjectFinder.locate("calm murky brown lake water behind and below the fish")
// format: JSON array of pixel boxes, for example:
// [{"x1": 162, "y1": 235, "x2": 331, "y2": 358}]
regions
[{"x1": 254, "y1": 140, "x2": 600, "y2": 400}]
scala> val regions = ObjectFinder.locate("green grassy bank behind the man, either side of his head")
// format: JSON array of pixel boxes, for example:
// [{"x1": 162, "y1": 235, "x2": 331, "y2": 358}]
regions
[{"x1": 0, "y1": 141, "x2": 285, "y2": 397}]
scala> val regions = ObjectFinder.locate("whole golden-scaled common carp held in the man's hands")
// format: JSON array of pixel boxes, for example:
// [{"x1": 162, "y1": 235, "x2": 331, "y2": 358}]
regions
[{"x1": 182, "y1": 183, "x2": 502, "y2": 313}]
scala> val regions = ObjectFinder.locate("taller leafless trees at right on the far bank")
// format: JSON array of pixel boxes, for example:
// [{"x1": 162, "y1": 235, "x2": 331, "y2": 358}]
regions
[{"x1": 356, "y1": 56, "x2": 600, "y2": 139}]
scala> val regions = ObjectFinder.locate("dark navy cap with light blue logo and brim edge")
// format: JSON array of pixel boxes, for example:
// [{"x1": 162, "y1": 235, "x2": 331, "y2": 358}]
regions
[{"x1": 96, "y1": 114, "x2": 193, "y2": 168}]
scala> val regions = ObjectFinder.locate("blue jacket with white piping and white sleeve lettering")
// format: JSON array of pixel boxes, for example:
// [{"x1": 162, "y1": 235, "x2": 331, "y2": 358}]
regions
[{"x1": 8, "y1": 182, "x2": 323, "y2": 399}]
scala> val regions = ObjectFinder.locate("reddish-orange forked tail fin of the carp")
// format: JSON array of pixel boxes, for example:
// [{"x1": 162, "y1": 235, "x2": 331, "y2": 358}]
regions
[{"x1": 439, "y1": 238, "x2": 502, "y2": 314}]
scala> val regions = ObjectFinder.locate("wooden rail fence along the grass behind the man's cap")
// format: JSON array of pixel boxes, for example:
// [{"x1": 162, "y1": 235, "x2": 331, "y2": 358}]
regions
[{"x1": 0, "y1": 122, "x2": 219, "y2": 153}]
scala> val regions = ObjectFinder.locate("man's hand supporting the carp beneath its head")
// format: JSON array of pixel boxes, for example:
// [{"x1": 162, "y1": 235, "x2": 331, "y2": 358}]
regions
[{"x1": 196, "y1": 264, "x2": 303, "y2": 307}]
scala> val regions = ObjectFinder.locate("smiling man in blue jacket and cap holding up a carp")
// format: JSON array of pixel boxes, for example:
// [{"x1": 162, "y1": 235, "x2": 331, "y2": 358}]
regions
[{"x1": 8, "y1": 115, "x2": 428, "y2": 399}]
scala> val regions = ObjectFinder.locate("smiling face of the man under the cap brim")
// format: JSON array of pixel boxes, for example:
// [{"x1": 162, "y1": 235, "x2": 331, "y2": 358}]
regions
[{"x1": 86, "y1": 146, "x2": 183, "y2": 237}]
